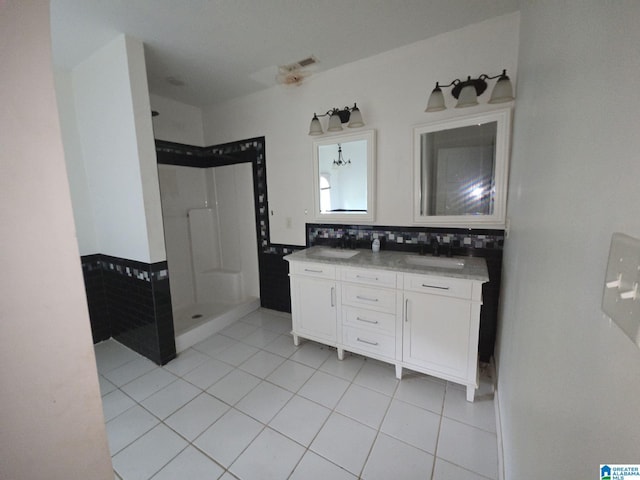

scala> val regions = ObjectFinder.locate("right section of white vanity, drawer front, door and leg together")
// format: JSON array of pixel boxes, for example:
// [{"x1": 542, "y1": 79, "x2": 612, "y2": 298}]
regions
[{"x1": 402, "y1": 274, "x2": 482, "y2": 402}]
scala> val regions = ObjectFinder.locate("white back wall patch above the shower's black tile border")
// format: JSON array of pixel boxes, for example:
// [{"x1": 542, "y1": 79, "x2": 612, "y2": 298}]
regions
[{"x1": 149, "y1": 94, "x2": 207, "y2": 147}]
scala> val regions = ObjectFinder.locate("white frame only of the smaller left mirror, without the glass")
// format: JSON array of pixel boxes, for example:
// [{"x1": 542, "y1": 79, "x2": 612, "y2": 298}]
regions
[{"x1": 313, "y1": 130, "x2": 376, "y2": 223}]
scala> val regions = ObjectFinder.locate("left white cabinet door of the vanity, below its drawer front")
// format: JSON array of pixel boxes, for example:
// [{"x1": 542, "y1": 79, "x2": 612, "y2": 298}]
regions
[{"x1": 291, "y1": 277, "x2": 337, "y2": 345}]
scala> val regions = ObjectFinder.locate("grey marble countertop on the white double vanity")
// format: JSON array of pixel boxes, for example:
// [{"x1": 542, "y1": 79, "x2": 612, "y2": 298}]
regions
[{"x1": 284, "y1": 246, "x2": 489, "y2": 282}]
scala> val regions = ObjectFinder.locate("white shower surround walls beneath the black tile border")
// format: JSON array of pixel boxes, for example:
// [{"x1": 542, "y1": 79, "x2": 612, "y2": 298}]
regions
[{"x1": 158, "y1": 163, "x2": 259, "y2": 311}]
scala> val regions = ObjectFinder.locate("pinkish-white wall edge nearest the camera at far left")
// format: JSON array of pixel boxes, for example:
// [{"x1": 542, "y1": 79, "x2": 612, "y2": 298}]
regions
[{"x1": 0, "y1": 0, "x2": 113, "y2": 480}]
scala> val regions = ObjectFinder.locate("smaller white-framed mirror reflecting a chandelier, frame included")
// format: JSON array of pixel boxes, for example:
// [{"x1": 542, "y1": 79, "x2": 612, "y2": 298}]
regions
[{"x1": 313, "y1": 130, "x2": 376, "y2": 223}]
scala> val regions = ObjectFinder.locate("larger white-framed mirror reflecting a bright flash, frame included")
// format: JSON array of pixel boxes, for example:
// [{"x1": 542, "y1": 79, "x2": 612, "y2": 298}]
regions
[{"x1": 413, "y1": 108, "x2": 511, "y2": 228}]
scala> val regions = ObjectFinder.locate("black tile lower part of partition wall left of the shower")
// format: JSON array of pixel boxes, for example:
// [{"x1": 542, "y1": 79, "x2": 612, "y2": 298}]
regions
[{"x1": 82, "y1": 254, "x2": 176, "y2": 365}]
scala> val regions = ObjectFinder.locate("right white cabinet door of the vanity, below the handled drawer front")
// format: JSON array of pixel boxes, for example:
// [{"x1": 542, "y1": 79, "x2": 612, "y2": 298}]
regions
[{"x1": 403, "y1": 292, "x2": 472, "y2": 379}]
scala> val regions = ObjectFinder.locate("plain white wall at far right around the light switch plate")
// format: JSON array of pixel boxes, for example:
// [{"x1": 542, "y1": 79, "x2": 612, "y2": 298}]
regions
[{"x1": 498, "y1": 0, "x2": 640, "y2": 479}]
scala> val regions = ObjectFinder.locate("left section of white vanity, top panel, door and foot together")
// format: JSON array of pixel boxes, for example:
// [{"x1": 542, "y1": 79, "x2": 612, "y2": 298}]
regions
[{"x1": 291, "y1": 262, "x2": 339, "y2": 347}]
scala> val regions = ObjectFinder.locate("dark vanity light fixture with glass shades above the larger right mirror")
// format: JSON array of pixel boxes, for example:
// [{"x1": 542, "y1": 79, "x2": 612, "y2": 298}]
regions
[{"x1": 425, "y1": 70, "x2": 514, "y2": 112}]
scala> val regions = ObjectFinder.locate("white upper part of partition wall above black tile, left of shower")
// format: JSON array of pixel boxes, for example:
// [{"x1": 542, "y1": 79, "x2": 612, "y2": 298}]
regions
[{"x1": 71, "y1": 35, "x2": 166, "y2": 263}]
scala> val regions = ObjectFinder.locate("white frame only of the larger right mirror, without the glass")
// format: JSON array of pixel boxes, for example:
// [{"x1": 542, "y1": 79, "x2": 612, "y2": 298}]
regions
[{"x1": 413, "y1": 108, "x2": 511, "y2": 228}]
